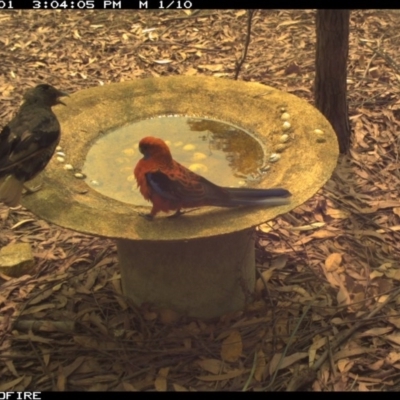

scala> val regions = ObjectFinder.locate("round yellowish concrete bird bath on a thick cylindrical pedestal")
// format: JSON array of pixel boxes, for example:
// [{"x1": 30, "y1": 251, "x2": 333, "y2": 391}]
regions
[{"x1": 22, "y1": 76, "x2": 338, "y2": 318}]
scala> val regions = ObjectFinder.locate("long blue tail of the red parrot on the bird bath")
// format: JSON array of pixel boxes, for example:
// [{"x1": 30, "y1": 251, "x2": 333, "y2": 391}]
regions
[{"x1": 216, "y1": 188, "x2": 291, "y2": 207}]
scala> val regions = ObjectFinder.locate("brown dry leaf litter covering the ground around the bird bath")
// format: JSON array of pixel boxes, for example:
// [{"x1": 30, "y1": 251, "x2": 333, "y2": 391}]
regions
[{"x1": 0, "y1": 10, "x2": 400, "y2": 391}]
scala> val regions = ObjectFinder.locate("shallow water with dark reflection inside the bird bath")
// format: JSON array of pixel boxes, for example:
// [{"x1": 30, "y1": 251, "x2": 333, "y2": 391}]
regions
[{"x1": 83, "y1": 116, "x2": 265, "y2": 205}]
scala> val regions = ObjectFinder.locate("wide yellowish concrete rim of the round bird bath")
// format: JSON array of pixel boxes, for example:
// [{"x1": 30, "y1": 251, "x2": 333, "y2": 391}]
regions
[{"x1": 22, "y1": 76, "x2": 338, "y2": 241}]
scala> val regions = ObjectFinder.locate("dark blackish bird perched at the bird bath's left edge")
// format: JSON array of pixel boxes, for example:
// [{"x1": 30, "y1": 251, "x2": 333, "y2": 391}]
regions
[{"x1": 0, "y1": 84, "x2": 68, "y2": 207}]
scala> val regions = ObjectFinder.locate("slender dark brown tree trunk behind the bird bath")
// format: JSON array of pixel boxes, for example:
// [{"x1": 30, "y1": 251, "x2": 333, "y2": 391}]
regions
[{"x1": 314, "y1": 10, "x2": 351, "y2": 153}]
